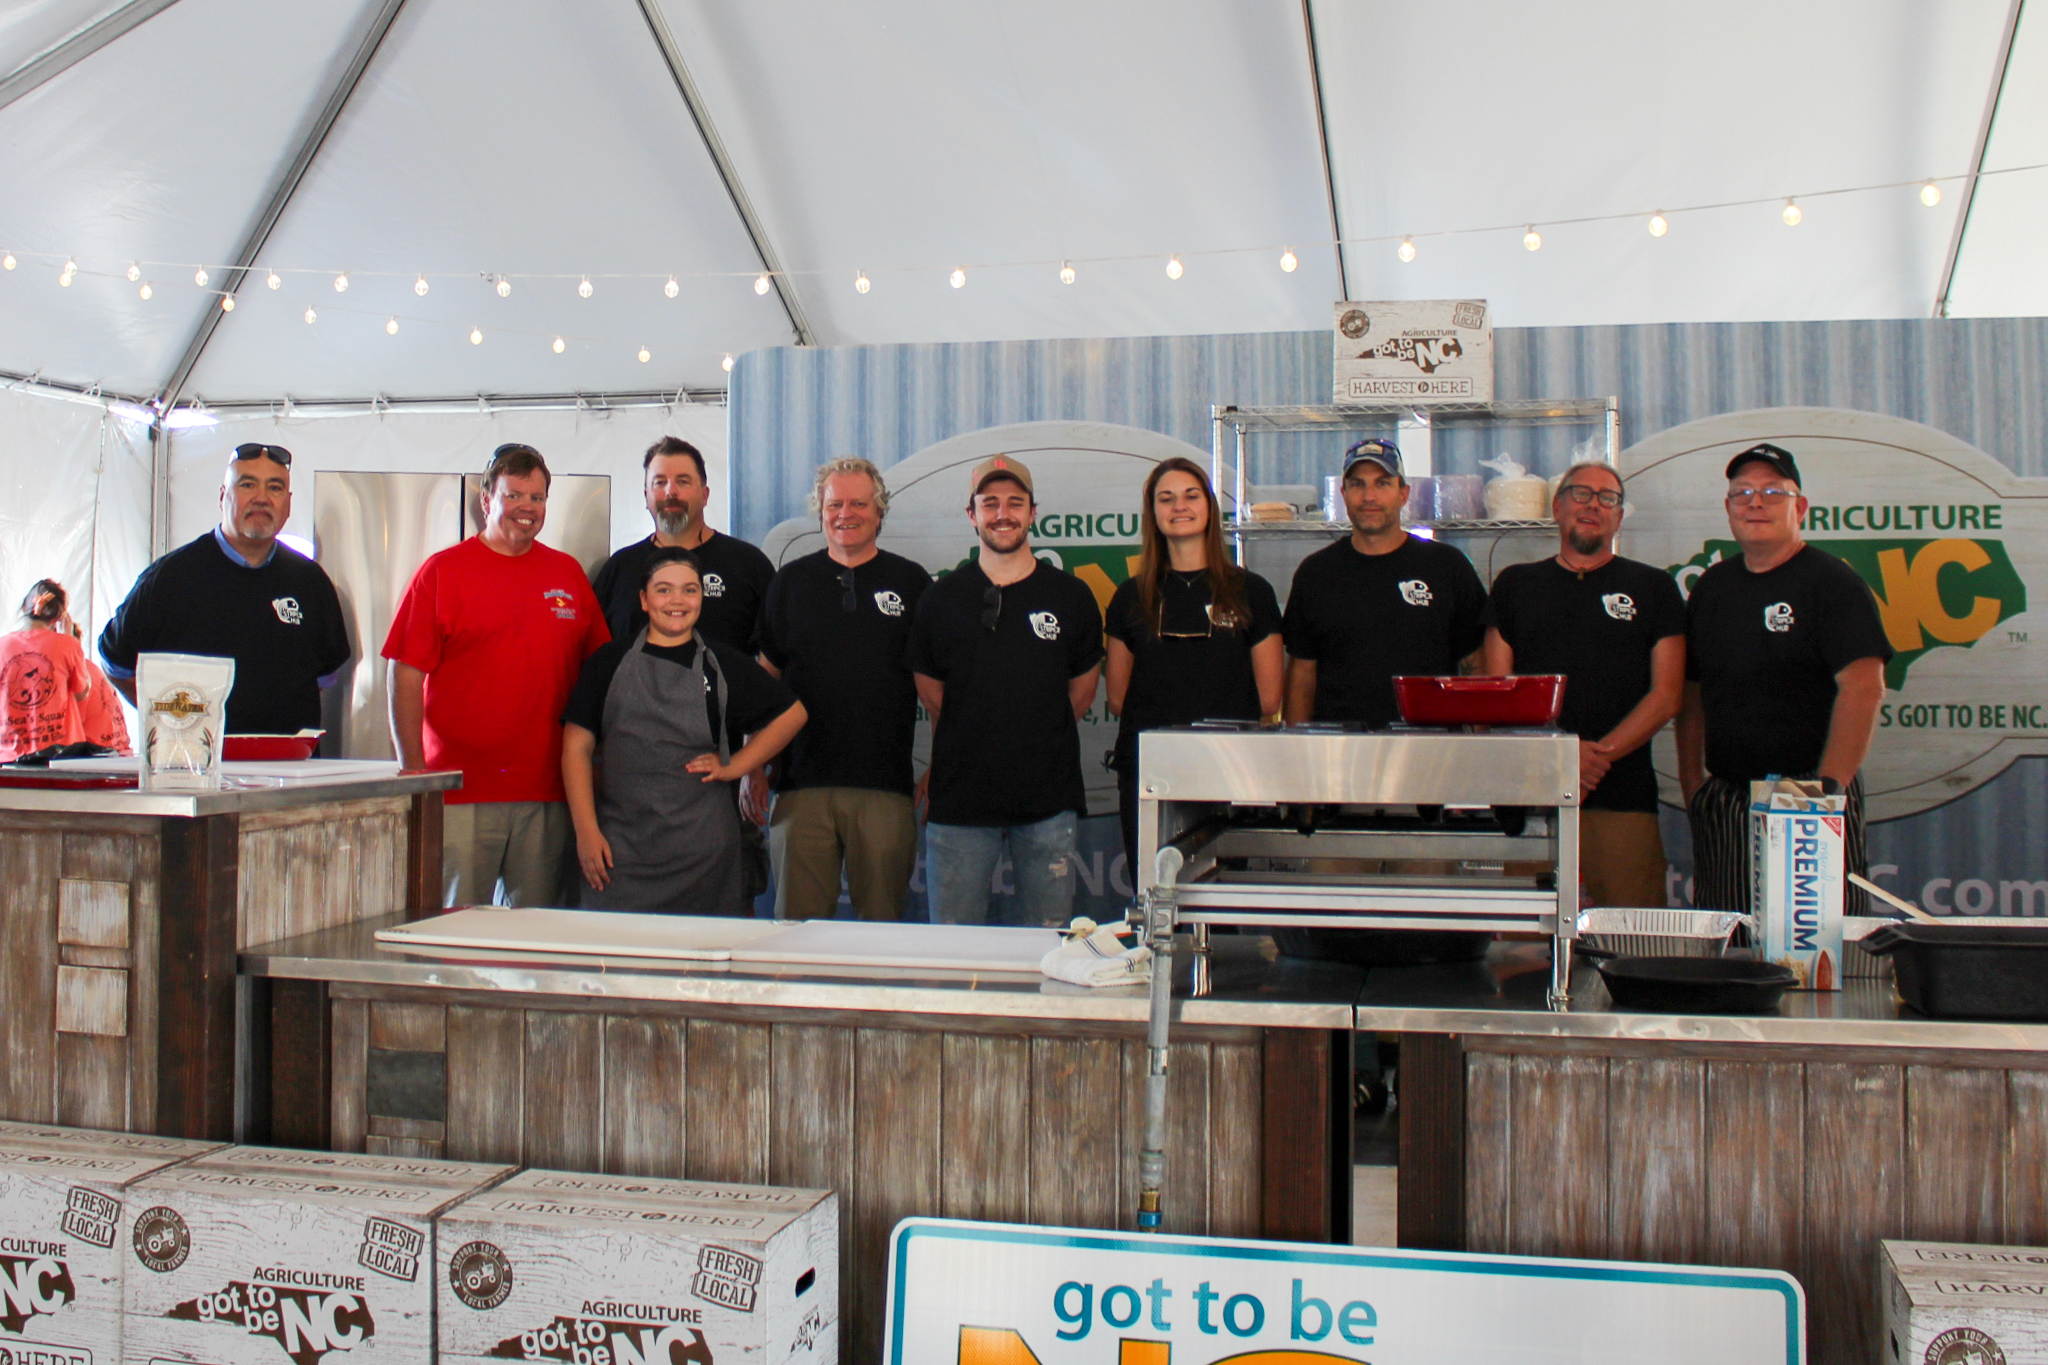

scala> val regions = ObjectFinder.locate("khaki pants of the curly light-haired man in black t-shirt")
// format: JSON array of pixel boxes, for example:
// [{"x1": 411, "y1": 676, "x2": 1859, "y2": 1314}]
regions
[{"x1": 768, "y1": 786, "x2": 918, "y2": 919}]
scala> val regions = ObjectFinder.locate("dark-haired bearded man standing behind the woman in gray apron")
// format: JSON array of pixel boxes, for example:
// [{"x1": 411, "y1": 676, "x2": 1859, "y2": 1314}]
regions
[{"x1": 590, "y1": 436, "x2": 774, "y2": 655}]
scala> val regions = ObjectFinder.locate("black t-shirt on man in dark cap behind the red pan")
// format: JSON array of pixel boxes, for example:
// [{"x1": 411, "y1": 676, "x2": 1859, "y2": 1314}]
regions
[{"x1": 1286, "y1": 536, "x2": 1487, "y2": 729}]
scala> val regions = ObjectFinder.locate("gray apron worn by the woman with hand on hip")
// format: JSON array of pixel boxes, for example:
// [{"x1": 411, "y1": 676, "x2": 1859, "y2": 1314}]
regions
[{"x1": 584, "y1": 628, "x2": 748, "y2": 915}]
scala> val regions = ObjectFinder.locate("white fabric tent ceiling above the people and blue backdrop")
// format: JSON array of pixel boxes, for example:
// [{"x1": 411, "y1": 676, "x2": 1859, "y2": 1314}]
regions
[{"x1": 0, "y1": 0, "x2": 2048, "y2": 401}]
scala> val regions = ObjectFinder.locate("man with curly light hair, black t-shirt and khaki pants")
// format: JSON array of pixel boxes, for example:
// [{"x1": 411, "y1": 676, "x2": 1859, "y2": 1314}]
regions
[{"x1": 748, "y1": 456, "x2": 932, "y2": 919}]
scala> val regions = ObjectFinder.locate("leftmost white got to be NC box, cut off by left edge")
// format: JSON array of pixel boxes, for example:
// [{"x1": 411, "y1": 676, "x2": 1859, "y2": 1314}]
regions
[{"x1": 0, "y1": 1124, "x2": 221, "y2": 1365}]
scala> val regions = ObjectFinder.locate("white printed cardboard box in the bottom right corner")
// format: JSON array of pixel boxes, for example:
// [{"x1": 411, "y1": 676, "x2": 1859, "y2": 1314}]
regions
[{"x1": 1878, "y1": 1242, "x2": 2048, "y2": 1365}]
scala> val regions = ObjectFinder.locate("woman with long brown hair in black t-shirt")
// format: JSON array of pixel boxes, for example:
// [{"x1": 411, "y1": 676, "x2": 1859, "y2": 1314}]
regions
[{"x1": 1106, "y1": 456, "x2": 1284, "y2": 863}]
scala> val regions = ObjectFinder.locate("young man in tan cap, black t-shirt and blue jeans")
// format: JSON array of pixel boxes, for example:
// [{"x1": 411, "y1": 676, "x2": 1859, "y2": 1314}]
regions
[{"x1": 909, "y1": 454, "x2": 1102, "y2": 925}]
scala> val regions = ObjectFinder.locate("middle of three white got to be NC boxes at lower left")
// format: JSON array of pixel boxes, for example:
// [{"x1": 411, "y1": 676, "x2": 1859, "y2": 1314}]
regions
[{"x1": 121, "y1": 1146, "x2": 512, "y2": 1365}]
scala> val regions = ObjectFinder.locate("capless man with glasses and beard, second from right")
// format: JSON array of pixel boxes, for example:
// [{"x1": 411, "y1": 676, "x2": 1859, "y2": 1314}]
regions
[{"x1": 1485, "y1": 463, "x2": 1686, "y2": 907}]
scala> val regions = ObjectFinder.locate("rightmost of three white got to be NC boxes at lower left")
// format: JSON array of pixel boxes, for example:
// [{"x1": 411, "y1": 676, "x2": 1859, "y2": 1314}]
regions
[{"x1": 436, "y1": 1171, "x2": 840, "y2": 1365}]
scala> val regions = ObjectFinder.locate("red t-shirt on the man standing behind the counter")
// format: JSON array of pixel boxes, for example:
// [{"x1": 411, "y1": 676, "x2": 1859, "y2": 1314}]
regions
[{"x1": 383, "y1": 536, "x2": 612, "y2": 804}]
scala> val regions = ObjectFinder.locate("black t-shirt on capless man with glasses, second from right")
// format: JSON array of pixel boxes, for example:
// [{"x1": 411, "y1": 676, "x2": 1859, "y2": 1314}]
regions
[{"x1": 1487, "y1": 557, "x2": 1686, "y2": 812}]
